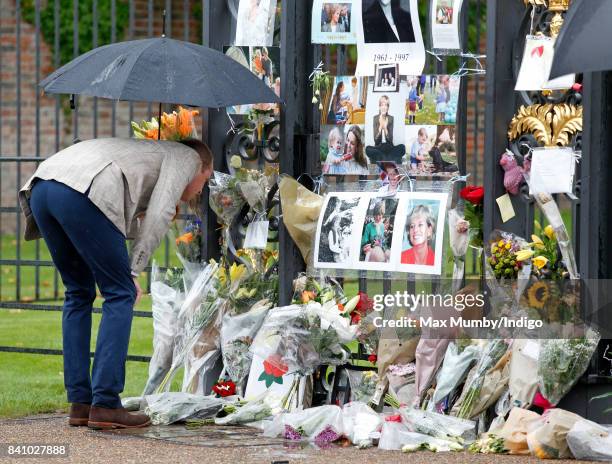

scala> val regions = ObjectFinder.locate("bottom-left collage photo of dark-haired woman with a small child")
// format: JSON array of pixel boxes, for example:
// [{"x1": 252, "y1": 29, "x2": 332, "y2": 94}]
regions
[{"x1": 320, "y1": 124, "x2": 370, "y2": 176}]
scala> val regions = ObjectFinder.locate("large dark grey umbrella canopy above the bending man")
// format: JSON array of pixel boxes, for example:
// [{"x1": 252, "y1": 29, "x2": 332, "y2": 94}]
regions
[{"x1": 39, "y1": 37, "x2": 280, "y2": 108}]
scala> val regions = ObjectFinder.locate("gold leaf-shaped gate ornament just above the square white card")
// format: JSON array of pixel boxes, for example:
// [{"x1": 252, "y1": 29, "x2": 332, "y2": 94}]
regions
[{"x1": 508, "y1": 103, "x2": 582, "y2": 147}]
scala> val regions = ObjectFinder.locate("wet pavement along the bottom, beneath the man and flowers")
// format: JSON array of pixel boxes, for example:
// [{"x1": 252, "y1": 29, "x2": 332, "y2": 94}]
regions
[{"x1": 0, "y1": 414, "x2": 582, "y2": 464}]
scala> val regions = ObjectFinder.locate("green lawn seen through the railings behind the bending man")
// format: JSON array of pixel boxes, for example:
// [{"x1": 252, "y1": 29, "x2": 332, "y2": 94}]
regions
[{"x1": 0, "y1": 235, "x2": 181, "y2": 418}]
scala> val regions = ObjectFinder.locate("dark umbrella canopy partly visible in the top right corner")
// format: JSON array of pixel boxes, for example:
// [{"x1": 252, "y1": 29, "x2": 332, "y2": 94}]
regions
[{"x1": 550, "y1": 0, "x2": 612, "y2": 79}]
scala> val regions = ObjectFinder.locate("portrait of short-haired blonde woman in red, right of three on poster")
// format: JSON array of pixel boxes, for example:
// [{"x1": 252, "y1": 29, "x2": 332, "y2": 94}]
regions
[{"x1": 394, "y1": 192, "x2": 448, "y2": 275}]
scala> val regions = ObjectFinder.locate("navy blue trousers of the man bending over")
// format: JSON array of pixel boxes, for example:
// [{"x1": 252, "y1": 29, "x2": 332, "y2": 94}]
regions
[{"x1": 30, "y1": 180, "x2": 136, "y2": 408}]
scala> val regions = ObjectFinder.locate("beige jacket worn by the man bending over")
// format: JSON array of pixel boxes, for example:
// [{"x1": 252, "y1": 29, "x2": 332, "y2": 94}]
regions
[{"x1": 19, "y1": 138, "x2": 201, "y2": 273}]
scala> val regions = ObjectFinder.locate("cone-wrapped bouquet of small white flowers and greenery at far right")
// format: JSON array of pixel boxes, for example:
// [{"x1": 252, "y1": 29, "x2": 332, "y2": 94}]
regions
[{"x1": 538, "y1": 330, "x2": 600, "y2": 405}]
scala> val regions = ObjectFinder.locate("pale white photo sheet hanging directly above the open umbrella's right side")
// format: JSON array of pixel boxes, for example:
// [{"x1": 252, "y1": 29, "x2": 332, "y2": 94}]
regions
[{"x1": 234, "y1": 0, "x2": 277, "y2": 47}]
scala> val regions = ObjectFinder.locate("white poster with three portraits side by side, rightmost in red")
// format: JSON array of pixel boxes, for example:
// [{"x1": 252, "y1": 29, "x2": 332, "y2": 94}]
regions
[{"x1": 314, "y1": 192, "x2": 448, "y2": 275}]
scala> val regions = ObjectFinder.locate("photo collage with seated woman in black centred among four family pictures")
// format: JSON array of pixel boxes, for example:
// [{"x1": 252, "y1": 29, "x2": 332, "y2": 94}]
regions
[{"x1": 320, "y1": 72, "x2": 460, "y2": 177}]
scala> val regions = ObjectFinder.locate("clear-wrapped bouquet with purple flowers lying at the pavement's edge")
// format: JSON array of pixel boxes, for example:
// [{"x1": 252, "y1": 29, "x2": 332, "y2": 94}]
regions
[{"x1": 263, "y1": 405, "x2": 344, "y2": 445}]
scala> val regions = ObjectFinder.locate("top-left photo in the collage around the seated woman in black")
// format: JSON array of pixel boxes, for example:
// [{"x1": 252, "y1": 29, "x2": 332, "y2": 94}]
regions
[{"x1": 327, "y1": 76, "x2": 368, "y2": 125}]
